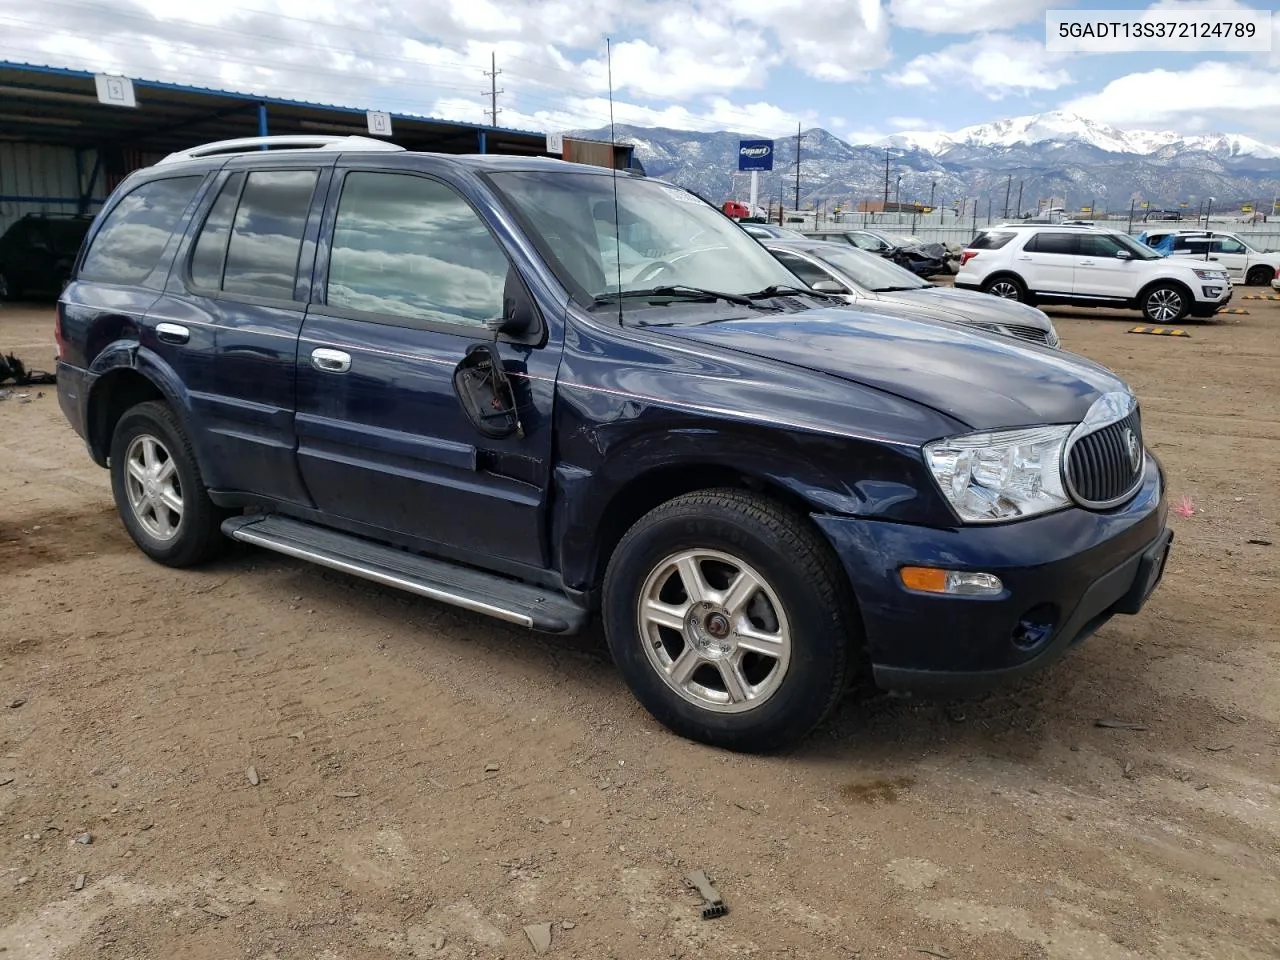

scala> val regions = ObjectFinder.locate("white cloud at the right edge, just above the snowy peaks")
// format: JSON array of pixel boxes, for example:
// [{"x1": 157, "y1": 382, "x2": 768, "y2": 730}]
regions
[{"x1": 1062, "y1": 60, "x2": 1280, "y2": 133}]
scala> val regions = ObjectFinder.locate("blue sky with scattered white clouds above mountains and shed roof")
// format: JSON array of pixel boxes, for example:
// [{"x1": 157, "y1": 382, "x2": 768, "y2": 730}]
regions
[{"x1": 0, "y1": 0, "x2": 1280, "y2": 143}]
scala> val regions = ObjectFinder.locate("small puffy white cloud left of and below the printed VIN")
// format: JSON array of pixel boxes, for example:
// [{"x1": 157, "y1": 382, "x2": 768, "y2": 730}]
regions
[{"x1": 888, "y1": 33, "x2": 1073, "y2": 100}]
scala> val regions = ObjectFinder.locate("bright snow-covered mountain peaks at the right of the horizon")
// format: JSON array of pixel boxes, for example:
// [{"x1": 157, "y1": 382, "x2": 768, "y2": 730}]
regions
[{"x1": 876, "y1": 110, "x2": 1280, "y2": 160}]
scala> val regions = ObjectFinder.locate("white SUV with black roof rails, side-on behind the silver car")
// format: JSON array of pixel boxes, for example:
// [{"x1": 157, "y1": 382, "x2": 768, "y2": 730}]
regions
[{"x1": 955, "y1": 224, "x2": 1231, "y2": 324}]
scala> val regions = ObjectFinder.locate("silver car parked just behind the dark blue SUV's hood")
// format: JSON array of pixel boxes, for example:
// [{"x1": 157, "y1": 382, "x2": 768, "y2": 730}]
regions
[{"x1": 760, "y1": 239, "x2": 1059, "y2": 347}]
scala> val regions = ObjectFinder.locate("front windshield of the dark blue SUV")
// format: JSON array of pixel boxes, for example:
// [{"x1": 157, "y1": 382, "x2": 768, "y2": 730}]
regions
[{"x1": 490, "y1": 170, "x2": 797, "y2": 303}]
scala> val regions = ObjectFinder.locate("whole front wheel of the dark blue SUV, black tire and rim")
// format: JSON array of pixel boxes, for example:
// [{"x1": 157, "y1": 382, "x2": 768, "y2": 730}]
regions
[{"x1": 603, "y1": 489, "x2": 860, "y2": 753}]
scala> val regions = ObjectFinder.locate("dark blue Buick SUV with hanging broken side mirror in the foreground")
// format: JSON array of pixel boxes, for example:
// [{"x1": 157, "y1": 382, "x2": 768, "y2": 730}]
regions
[{"x1": 56, "y1": 138, "x2": 1171, "y2": 750}]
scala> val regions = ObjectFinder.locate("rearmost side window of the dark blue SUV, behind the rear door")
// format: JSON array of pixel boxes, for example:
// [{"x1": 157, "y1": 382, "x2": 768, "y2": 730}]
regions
[{"x1": 79, "y1": 174, "x2": 205, "y2": 283}]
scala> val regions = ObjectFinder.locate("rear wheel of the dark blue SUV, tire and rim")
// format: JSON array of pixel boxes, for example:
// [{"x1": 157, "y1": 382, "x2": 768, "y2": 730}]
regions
[{"x1": 110, "y1": 402, "x2": 227, "y2": 567}]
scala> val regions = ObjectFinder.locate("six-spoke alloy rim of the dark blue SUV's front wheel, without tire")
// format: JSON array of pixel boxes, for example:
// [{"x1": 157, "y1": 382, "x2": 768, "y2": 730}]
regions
[{"x1": 637, "y1": 550, "x2": 792, "y2": 713}]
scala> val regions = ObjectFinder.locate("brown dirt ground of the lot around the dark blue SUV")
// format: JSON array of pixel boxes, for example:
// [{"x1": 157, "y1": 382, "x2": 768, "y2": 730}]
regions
[{"x1": 0, "y1": 289, "x2": 1280, "y2": 960}]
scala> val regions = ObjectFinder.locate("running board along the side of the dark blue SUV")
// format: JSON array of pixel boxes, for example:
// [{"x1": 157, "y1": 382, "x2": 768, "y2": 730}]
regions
[{"x1": 223, "y1": 515, "x2": 588, "y2": 634}]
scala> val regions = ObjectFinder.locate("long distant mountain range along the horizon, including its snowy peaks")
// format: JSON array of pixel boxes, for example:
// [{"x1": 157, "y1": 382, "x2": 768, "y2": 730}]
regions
[{"x1": 579, "y1": 113, "x2": 1280, "y2": 216}]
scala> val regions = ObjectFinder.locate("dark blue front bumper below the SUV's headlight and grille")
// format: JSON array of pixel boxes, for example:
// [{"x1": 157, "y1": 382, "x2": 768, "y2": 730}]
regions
[{"x1": 815, "y1": 454, "x2": 1172, "y2": 694}]
